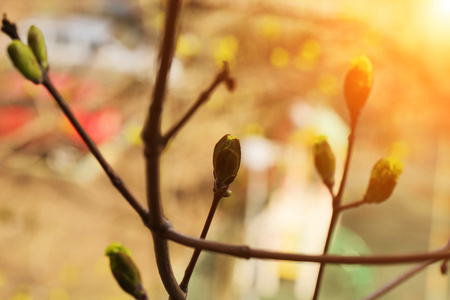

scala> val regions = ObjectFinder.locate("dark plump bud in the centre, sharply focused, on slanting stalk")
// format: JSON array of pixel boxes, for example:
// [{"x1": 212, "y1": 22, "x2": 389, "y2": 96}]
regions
[{"x1": 213, "y1": 134, "x2": 241, "y2": 185}]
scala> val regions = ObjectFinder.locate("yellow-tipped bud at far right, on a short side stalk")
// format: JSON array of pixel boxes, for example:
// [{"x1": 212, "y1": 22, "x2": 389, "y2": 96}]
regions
[{"x1": 364, "y1": 157, "x2": 403, "y2": 203}]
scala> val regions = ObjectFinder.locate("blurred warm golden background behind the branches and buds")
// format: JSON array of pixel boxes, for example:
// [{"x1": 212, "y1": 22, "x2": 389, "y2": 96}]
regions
[{"x1": 0, "y1": 0, "x2": 450, "y2": 300}]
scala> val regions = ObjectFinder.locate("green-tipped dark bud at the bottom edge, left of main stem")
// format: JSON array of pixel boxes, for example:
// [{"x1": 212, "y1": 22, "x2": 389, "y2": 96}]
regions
[{"x1": 105, "y1": 243, "x2": 146, "y2": 299}]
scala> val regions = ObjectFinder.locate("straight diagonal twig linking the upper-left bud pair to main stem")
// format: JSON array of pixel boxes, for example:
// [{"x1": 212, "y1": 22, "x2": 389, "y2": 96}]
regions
[{"x1": 42, "y1": 73, "x2": 148, "y2": 224}]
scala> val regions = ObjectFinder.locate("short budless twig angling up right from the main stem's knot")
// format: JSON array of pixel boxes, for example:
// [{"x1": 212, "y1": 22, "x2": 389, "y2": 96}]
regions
[{"x1": 163, "y1": 62, "x2": 232, "y2": 144}]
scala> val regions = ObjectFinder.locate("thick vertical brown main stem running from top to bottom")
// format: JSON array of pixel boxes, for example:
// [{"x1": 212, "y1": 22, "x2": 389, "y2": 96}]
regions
[{"x1": 142, "y1": 0, "x2": 186, "y2": 300}]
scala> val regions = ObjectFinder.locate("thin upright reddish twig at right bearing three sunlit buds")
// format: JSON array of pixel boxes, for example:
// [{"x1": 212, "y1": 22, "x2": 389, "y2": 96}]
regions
[{"x1": 312, "y1": 119, "x2": 357, "y2": 300}]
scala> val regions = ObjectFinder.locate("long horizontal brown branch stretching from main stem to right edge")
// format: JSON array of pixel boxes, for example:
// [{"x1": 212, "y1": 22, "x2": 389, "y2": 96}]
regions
[{"x1": 163, "y1": 227, "x2": 450, "y2": 265}]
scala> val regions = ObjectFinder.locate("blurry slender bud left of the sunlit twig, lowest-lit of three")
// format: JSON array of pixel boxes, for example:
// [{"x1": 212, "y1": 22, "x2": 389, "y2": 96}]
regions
[{"x1": 314, "y1": 136, "x2": 336, "y2": 189}]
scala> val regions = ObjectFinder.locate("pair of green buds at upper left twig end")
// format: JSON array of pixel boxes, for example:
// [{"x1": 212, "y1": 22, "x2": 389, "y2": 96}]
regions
[{"x1": 7, "y1": 25, "x2": 49, "y2": 84}]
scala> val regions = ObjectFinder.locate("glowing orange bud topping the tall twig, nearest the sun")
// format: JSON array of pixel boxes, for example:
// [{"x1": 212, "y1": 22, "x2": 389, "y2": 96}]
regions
[{"x1": 344, "y1": 55, "x2": 373, "y2": 121}]
